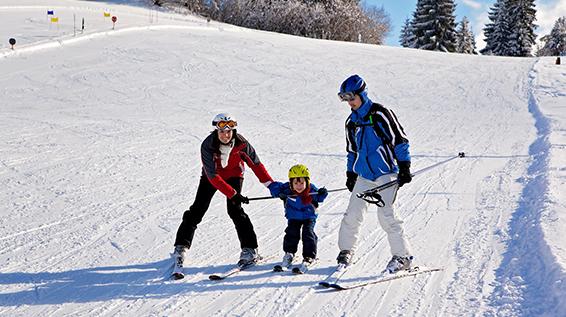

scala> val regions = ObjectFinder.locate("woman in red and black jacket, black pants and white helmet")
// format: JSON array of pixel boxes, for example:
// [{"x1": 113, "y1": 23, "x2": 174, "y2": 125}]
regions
[{"x1": 173, "y1": 113, "x2": 273, "y2": 277}]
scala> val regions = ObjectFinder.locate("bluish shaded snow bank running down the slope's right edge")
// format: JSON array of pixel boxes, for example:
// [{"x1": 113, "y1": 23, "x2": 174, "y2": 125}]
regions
[{"x1": 490, "y1": 59, "x2": 566, "y2": 316}]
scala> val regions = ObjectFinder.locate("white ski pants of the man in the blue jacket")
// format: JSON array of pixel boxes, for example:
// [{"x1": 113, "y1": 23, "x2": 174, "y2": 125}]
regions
[{"x1": 338, "y1": 174, "x2": 412, "y2": 256}]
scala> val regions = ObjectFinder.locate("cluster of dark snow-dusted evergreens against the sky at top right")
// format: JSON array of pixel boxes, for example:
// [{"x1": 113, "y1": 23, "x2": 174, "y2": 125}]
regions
[{"x1": 399, "y1": 0, "x2": 566, "y2": 56}]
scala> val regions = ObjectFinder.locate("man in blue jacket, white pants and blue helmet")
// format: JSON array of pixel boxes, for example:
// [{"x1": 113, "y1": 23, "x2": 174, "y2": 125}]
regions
[{"x1": 337, "y1": 75, "x2": 413, "y2": 273}]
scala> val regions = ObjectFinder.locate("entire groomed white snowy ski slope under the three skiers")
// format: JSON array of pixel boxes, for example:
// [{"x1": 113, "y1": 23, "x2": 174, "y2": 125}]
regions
[{"x1": 0, "y1": 0, "x2": 566, "y2": 316}]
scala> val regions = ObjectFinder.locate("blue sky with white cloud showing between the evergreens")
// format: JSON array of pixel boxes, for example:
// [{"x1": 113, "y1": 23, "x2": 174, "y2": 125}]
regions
[{"x1": 366, "y1": 0, "x2": 566, "y2": 48}]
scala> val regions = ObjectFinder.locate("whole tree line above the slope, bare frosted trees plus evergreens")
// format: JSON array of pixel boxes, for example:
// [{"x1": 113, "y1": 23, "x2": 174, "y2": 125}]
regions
[{"x1": 155, "y1": 0, "x2": 566, "y2": 56}]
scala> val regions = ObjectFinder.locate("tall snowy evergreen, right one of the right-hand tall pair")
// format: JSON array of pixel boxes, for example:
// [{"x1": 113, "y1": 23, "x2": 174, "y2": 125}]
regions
[{"x1": 504, "y1": 0, "x2": 536, "y2": 56}]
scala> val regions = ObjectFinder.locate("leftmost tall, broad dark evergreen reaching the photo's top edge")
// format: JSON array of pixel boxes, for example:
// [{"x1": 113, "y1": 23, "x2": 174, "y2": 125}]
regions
[{"x1": 414, "y1": 0, "x2": 462, "y2": 52}]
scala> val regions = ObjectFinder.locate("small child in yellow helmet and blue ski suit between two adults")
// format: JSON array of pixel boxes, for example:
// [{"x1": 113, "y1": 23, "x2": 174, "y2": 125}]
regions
[{"x1": 269, "y1": 164, "x2": 328, "y2": 273}]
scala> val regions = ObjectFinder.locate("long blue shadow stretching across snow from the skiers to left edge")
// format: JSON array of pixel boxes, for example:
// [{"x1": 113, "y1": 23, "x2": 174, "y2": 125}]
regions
[{"x1": 0, "y1": 259, "x2": 331, "y2": 307}]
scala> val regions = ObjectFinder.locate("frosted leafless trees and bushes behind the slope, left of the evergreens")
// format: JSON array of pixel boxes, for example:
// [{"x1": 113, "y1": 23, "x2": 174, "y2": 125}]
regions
[{"x1": 153, "y1": 0, "x2": 391, "y2": 44}]
